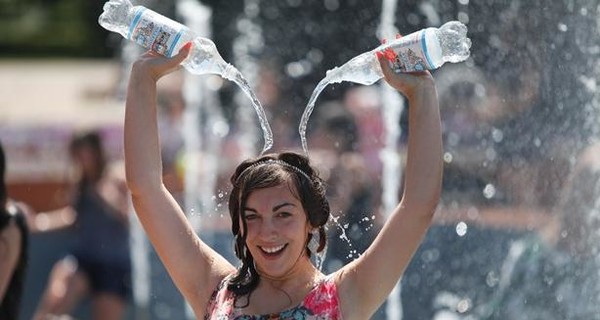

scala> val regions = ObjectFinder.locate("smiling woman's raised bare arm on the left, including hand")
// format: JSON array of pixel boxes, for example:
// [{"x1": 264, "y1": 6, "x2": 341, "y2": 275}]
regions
[{"x1": 125, "y1": 46, "x2": 234, "y2": 318}]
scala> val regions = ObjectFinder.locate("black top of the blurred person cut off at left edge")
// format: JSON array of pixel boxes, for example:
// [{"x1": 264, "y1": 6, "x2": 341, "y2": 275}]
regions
[{"x1": 0, "y1": 205, "x2": 29, "y2": 319}]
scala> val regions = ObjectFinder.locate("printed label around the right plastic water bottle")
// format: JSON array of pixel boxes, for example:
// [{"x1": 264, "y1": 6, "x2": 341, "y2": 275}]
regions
[{"x1": 381, "y1": 30, "x2": 435, "y2": 72}]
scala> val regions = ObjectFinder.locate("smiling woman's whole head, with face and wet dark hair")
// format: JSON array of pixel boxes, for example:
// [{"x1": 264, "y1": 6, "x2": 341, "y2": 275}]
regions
[{"x1": 229, "y1": 153, "x2": 329, "y2": 304}]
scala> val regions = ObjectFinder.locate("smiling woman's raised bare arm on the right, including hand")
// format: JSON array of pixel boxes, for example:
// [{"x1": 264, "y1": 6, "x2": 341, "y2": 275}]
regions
[{"x1": 336, "y1": 52, "x2": 442, "y2": 319}]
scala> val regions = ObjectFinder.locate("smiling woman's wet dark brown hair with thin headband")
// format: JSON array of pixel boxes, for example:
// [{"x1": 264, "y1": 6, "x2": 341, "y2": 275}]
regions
[{"x1": 227, "y1": 152, "x2": 329, "y2": 296}]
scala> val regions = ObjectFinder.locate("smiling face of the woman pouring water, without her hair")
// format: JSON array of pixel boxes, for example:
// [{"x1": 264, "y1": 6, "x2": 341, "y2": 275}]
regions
[{"x1": 243, "y1": 184, "x2": 310, "y2": 277}]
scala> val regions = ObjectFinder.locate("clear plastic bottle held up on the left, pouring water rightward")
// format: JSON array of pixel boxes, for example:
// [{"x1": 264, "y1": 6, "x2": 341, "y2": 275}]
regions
[{"x1": 98, "y1": 0, "x2": 236, "y2": 80}]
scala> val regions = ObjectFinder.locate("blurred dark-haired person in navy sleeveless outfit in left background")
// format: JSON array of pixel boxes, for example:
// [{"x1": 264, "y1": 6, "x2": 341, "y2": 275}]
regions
[{"x1": 33, "y1": 131, "x2": 131, "y2": 320}]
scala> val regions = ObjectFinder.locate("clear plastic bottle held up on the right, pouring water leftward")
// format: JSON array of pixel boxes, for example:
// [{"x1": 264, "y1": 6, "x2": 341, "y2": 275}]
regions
[{"x1": 325, "y1": 21, "x2": 471, "y2": 85}]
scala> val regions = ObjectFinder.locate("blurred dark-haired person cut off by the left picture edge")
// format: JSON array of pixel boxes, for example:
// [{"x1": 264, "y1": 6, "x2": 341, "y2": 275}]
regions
[{"x1": 0, "y1": 143, "x2": 29, "y2": 320}]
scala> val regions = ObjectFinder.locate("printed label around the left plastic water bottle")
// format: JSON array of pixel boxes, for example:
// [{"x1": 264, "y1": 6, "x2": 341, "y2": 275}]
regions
[{"x1": 128, "y1": 7, "x2": 186, "y2": 57}]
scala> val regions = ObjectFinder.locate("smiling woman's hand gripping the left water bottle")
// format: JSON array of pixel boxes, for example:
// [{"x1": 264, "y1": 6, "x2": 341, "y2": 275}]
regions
[{"x1": 132, "y1": 42, "x2": 192, "y2": 82}]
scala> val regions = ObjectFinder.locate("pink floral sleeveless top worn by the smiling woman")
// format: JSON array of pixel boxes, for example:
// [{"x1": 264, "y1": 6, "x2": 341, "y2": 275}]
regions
[{"x1": 204, "y1": 277, "x2": 342, "y2": 320}]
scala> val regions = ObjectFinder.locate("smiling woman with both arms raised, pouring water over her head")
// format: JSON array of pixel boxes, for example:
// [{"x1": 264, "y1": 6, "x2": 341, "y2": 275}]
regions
[{"x1": 125, "y1": 42, "x2": 442, "y2": 320}]
